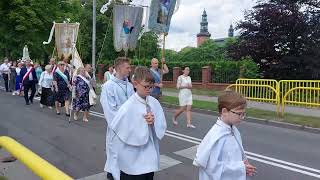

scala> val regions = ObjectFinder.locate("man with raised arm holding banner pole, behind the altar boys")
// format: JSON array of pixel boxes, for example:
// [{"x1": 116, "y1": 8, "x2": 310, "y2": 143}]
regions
[{"x1": 150, "y1": 58, "x2": 169, "y2": 100}]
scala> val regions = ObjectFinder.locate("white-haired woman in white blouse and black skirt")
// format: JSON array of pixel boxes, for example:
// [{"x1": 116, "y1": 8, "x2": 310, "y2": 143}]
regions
[{"x1": 39, "y1": 65, "x2": 54, "y2": 109}]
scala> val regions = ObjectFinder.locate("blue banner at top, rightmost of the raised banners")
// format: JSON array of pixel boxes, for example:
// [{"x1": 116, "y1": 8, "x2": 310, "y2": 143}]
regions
[{"x1": 149, "y1": 0, "x2": 176, "y2": 33}]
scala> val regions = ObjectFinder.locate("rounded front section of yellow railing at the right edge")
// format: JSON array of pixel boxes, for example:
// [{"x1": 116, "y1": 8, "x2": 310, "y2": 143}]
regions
[{"x1": 281, "y1": 87, "x2": 320, "y2": 116}]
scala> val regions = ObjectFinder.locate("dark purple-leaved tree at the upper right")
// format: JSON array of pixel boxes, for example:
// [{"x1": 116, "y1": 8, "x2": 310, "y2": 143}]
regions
[{"x1": 228, "y1": 0, "x2": 320, "y2": 79}]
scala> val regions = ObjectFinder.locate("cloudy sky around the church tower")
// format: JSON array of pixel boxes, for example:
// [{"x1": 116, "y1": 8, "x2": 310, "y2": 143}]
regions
[{"x1": 166, "y1": 0, "x2": 255, "y2": 51}]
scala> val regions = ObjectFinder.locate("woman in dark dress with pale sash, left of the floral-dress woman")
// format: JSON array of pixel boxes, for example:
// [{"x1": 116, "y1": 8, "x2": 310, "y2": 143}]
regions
[{"x1": 53, "y1": 61, "x2": 71, "y2": 117}]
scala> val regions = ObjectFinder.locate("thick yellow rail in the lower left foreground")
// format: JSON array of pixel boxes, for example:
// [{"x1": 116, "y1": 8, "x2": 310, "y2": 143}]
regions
[{"x1": 0, "y1": 136, "x2": 72, "y2": 180}]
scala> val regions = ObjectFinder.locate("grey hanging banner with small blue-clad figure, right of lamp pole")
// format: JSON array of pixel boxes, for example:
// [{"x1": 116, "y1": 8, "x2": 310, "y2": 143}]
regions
[{"x1": 113, "y1": 5, "x2": 143, "y2": 52}]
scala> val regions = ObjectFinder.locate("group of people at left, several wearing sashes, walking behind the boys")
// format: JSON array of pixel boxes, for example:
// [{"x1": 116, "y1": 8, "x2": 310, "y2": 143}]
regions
[{"x1": 0, "y1": 58, "x2": 96, "y2": 122}]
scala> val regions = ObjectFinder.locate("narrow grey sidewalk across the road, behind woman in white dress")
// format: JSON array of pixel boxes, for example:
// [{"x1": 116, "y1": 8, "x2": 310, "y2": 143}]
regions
[{"x1": 162, "y1": 91, "x2": 320, "y2": 120}]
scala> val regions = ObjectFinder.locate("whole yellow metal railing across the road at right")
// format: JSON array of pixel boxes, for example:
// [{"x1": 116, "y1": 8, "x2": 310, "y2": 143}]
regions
[{"x1": 227, "y1": 78, "x2": 320, "y2": 115}]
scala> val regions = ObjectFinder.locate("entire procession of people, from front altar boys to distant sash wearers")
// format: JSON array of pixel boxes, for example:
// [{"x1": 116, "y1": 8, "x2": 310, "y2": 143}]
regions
[{"x1": 0, "y1": 57, "x2": 256, "y2": 180}]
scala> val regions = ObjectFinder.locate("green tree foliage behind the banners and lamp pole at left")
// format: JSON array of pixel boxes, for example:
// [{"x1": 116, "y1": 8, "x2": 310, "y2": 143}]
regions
[{"x1": 0, "y1": 0, "x2": 159, "y2": 63}]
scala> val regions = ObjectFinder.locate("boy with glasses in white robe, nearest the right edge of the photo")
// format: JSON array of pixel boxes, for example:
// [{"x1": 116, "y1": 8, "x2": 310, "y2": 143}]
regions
[{"x1": 193, "y1": 91, "x2": 256, "y2": 180}]
